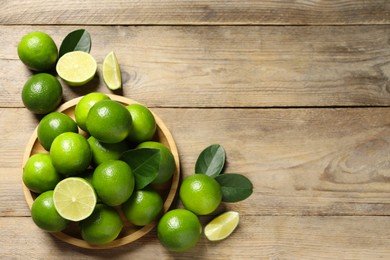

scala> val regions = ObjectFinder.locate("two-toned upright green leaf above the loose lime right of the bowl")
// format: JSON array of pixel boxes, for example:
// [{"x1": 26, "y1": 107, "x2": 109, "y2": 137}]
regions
[{"x1": 195, "y1": 144, "x2": 226, "y2": 178}]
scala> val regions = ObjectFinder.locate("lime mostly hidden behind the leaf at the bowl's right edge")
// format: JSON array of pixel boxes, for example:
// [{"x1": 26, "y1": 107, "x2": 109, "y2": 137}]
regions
[{"x1": 137, "y1": 141, "x2": 176, "y2": 184}]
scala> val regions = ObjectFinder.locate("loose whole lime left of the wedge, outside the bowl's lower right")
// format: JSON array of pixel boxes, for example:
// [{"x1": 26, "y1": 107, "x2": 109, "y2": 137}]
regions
[{"x1": 157, "y1": 209, "x2": 202, "y2": 252}]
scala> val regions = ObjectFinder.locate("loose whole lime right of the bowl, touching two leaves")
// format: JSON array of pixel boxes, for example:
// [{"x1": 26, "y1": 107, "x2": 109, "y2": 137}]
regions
[{"x1": 179, "y1": 174, "x2": 222, "y2": 215}]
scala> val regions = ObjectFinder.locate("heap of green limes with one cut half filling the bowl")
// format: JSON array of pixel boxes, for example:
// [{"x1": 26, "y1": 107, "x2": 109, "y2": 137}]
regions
[{"x1": 23, "y1": 92, "x2": 176, "y2": 245}]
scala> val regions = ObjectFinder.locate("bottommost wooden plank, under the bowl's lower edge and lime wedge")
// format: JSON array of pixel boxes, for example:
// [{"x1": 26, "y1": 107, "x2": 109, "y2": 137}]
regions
[{"x1": 0, "y1": 215, "x2": 390, "y2": 260}]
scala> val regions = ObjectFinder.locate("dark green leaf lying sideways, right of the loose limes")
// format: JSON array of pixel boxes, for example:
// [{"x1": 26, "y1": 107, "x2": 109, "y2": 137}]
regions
[{"x1": 215, "y1": 173, "x2": 253, "y2": 202}]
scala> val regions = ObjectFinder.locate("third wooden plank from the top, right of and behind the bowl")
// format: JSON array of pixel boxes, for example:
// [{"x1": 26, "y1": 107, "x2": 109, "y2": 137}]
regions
[{"x1": 4, "y1": 108, "x2": 390, "y2": 216}]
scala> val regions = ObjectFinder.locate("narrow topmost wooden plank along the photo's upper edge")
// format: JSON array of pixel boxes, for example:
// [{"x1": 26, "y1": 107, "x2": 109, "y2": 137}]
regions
[{"x1": 0, "y1": 0, "x2": 390, "y2": 25}]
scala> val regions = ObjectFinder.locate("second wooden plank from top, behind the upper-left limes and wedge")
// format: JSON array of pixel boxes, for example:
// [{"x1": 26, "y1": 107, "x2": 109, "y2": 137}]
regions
[{"x1": 0, "y1": 26, "x2": 390, "y2": 107}]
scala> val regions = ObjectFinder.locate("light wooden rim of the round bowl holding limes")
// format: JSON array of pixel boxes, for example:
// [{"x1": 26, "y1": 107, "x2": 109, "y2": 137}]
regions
[{"x1": 22, "y1": 94, "x2": 180, "y2": 249}]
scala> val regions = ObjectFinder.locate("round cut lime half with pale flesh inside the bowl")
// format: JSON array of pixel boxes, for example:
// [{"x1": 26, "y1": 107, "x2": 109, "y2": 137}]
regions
[{"x1": 53, "y1": 177, "x2": 96, "y2": 221}]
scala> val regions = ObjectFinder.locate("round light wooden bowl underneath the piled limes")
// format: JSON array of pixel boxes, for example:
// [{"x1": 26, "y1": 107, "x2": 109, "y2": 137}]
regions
[{"x1": 23, "y1": 95, "x2": 180, "y2": 249}]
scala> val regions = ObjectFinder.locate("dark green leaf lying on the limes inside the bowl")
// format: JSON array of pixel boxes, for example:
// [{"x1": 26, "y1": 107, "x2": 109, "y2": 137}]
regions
[{"x1": 120, "y1": 148, "x2": 161, "y2": 189}]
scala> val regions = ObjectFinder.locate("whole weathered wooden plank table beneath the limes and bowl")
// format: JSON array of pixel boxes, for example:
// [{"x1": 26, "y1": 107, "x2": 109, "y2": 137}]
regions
[{"x1": 0, "y1": 0, "x2": 390, "y2": 259}]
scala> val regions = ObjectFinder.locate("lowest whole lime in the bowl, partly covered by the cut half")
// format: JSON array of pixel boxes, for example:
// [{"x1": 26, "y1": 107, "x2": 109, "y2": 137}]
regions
[{"x1": 80, "y1": 204, "x2": 123, "y2": 245}]
